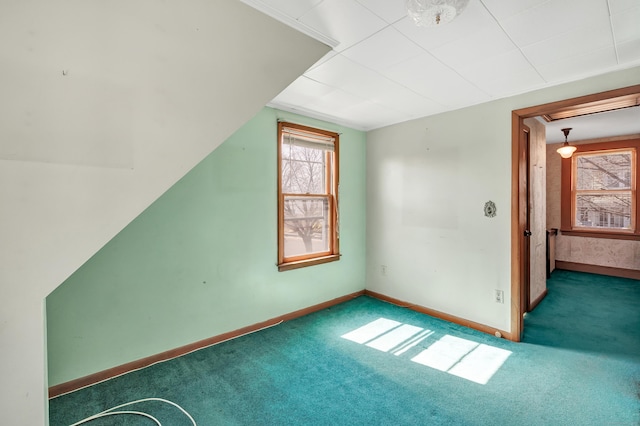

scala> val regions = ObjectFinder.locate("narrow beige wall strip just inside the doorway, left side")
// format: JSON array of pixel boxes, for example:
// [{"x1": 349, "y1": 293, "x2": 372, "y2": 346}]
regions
[{"x1": 524, "y1": 118, "x2": 547, "y2": 302}]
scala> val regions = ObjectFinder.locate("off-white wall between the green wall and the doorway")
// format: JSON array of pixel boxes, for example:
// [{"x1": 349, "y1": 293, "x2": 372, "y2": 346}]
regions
[{"x1": 366, "y1": 68, "x2": 640, "y2": 332}]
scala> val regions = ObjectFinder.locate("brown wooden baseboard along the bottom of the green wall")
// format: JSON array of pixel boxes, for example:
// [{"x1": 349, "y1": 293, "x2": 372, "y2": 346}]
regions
[{"x1": 49, "y1": 290, "x2": 365, "y2": 398}]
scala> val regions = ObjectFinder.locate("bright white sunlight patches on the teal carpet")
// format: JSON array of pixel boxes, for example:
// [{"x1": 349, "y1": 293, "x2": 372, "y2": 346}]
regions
[{"x1": 341, "y1": 318, "x2": 512, "y2": 385}]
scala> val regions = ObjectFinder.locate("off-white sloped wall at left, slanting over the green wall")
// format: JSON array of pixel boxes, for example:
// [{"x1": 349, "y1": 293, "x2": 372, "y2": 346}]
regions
[{"x1": 0, "y1": 0, "x2": 329, "y2": 425}]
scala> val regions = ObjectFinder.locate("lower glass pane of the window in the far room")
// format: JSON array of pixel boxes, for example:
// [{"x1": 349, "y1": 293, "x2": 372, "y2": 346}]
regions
[{"x1": 576, "y1": 191, "x2": 631, "y2": 229}]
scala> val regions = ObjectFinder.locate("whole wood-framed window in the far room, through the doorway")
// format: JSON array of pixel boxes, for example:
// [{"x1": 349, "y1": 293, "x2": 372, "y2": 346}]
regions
[{"x1": 561, "y1": 139, "x2": 640, "y2": 239}]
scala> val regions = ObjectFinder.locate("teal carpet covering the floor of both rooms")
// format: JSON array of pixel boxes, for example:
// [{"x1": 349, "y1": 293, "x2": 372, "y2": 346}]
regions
[{"x1": 50, "y1": 271, "x2": 640, "y2": 426}]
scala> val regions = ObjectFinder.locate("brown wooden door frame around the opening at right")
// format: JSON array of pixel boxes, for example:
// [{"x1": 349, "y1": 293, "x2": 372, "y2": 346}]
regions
[{"x1": 509, "y1": 84, "x2": 640, "y2": 342}]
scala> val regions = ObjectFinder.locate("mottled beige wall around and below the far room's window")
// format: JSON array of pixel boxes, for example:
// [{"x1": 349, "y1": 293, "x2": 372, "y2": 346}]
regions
[{"x1": 547, "y1": 140, "x2": 640, "y2": 270}]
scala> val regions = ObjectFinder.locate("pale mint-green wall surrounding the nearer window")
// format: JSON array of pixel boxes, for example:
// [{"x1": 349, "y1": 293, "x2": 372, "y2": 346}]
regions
[{"x1": 46, "y1": 108, "x2": 366, "y2": 386}]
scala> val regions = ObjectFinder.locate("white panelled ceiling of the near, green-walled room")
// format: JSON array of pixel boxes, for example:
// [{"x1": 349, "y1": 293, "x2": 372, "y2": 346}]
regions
[{"x1": 242, "y1": 0, "x2": 640, "y2": 131}]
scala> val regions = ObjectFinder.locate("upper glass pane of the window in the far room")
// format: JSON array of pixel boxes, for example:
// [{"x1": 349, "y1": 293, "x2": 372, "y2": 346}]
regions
[{"x1": 576, "y1": 151, "x2": 631, "y2": 190}]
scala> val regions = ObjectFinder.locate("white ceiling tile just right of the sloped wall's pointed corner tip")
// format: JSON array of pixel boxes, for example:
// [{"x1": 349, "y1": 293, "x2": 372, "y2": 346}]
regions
[{"x1": 342, "y1": 27, "x2": 424, "y2": 70}]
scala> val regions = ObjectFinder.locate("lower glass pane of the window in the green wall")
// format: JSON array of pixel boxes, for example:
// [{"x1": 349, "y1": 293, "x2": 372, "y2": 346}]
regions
[{"x1": 284, "y1": 196, "x2": 331, "y2": 257}]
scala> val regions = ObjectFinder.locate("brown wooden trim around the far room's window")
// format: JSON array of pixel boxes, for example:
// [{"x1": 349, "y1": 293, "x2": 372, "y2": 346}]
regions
[{"x1": 560, "y1": 138, "x2": 640, "y2": 240}]
